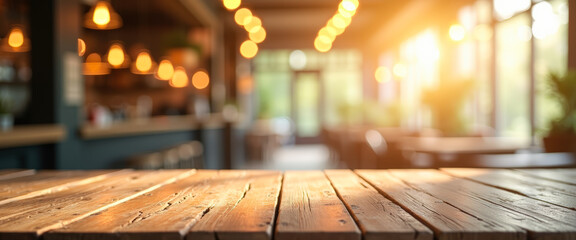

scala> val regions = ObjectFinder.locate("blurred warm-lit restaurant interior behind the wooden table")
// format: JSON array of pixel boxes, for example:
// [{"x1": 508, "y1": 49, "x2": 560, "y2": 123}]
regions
[{"x1": 0, "y1": 0, "x2": 576, "y2": 169}]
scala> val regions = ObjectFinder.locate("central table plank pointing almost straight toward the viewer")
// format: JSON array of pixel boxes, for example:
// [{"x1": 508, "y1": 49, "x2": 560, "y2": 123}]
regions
[{"x1": 274, "y1": 171, "x2": 361, "y2": 240}]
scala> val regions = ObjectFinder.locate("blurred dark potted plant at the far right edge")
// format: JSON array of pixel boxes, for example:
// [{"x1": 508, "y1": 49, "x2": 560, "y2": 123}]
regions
[{"x1": 542, "y1": 71, "x2": 576, "y2": 152}]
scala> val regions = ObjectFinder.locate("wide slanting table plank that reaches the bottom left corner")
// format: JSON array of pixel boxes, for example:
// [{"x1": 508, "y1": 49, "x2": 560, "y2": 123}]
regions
[{"x1": 0, "y1": 170, "x2": 194, "y2": 239}]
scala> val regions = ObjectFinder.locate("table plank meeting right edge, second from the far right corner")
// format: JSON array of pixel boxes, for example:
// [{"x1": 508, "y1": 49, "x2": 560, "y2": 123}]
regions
[{"x1": 442, "y1": 168, "x2": 576, "y2": 210}]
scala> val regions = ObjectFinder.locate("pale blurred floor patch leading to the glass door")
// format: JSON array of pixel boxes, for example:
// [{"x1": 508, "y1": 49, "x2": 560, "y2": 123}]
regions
[{"x1": 245, "y1": 144, "x2": 337, "y2": 170}]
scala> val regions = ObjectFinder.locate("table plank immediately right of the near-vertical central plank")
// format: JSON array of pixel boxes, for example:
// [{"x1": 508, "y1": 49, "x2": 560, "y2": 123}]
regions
[{"x1": 325, "y1": 170, "x2": 433, "y2": 240}]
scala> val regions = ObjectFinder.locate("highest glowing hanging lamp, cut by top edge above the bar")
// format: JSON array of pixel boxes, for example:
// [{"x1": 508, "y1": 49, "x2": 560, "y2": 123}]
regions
[{"x1": 84, "y1": 0, "x2": 122, "y2": 30}]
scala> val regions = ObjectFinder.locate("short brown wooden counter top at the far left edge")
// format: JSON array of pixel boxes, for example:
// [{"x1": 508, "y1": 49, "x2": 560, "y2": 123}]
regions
[{"x1": 0, "y1": 124, "x2": 66, "y2": 148}]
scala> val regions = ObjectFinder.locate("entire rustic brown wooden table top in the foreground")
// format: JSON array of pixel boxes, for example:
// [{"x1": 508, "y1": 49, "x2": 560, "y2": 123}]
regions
[{"x1": 0, "y1": 168, "x2": 576, "y2": 240}]
